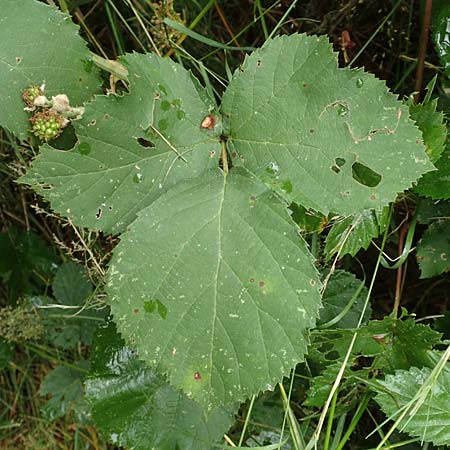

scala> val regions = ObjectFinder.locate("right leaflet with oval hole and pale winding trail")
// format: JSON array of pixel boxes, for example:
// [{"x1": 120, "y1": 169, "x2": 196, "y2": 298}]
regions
[{"x1": 221, "y1": 35, "x2": 433, "y2": 215}]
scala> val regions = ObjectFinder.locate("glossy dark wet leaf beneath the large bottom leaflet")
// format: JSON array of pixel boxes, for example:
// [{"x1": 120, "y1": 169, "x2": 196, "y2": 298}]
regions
[{"x1": 85, "y1": 325, "x2": 232, "y2": 450}]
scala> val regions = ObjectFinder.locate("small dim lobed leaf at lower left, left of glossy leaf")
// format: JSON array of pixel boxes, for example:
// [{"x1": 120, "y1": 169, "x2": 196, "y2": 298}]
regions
[{"x1": 39, "y1": 361, "x2": 87, "y2": 422}]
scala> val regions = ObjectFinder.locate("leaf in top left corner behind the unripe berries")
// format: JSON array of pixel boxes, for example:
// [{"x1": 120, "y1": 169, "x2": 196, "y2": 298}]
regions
[{"x1": 0, "y1": 0, "x2": 100, "y2": 138}]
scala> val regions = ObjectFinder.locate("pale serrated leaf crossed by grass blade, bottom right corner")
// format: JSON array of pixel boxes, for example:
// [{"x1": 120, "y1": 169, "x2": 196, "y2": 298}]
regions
[{"x1": 375, "y1": 367, "x2": 450, "y2": 445}]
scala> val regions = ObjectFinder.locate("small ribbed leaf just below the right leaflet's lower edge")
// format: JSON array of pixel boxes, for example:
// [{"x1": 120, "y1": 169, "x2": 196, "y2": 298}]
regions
[{"x1": 325, "y1": 207, "x2": 389, "y2": 260}]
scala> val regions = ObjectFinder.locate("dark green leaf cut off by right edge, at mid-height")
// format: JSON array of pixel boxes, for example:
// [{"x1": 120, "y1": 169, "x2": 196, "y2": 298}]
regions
[{"x1": 417, "y1": 220, "x2": 450, "y2": 278}]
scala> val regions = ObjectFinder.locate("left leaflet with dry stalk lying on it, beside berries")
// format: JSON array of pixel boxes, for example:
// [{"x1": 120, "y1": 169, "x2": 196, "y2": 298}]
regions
[{"x1": 21, "y1": 54, "x2": 220, "y2": 233}]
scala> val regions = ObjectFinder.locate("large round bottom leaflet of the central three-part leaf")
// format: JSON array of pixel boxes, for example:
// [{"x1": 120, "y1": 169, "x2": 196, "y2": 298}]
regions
[{"x1": 108, "y1": 168, "x2": 320, "y2": 409}]
